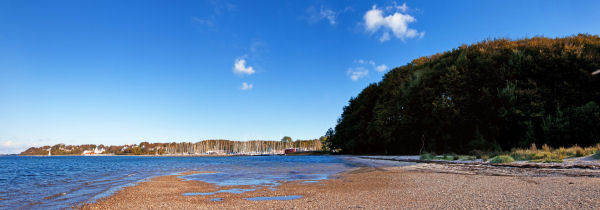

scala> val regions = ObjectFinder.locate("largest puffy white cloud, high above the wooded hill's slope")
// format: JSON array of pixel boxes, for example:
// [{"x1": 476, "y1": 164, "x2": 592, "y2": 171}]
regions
[{"x1": 364, "y1": 3, "x2": 425, "y2": 42}]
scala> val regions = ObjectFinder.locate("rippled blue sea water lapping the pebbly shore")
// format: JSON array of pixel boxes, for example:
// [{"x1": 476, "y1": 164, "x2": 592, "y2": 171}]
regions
[{"x1": 0, "y1": 156, "x2": 352, "y2": 209}]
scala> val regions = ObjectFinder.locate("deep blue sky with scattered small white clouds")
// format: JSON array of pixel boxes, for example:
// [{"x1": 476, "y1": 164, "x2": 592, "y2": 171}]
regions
[{"x1": 0, "y1": 0, "x2": 600, "y2": 153}]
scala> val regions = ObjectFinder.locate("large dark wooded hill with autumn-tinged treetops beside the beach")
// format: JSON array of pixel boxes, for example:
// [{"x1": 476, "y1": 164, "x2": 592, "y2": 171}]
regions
[{"x1": 326, "y1": 35, "x2": 600, "y2": 154}]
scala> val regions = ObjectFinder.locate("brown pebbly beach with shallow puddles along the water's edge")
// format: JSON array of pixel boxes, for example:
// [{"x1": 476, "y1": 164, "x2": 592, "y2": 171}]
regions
[{"x1": 81, "y1": 159, "x2": 600, "y2": 209}]
